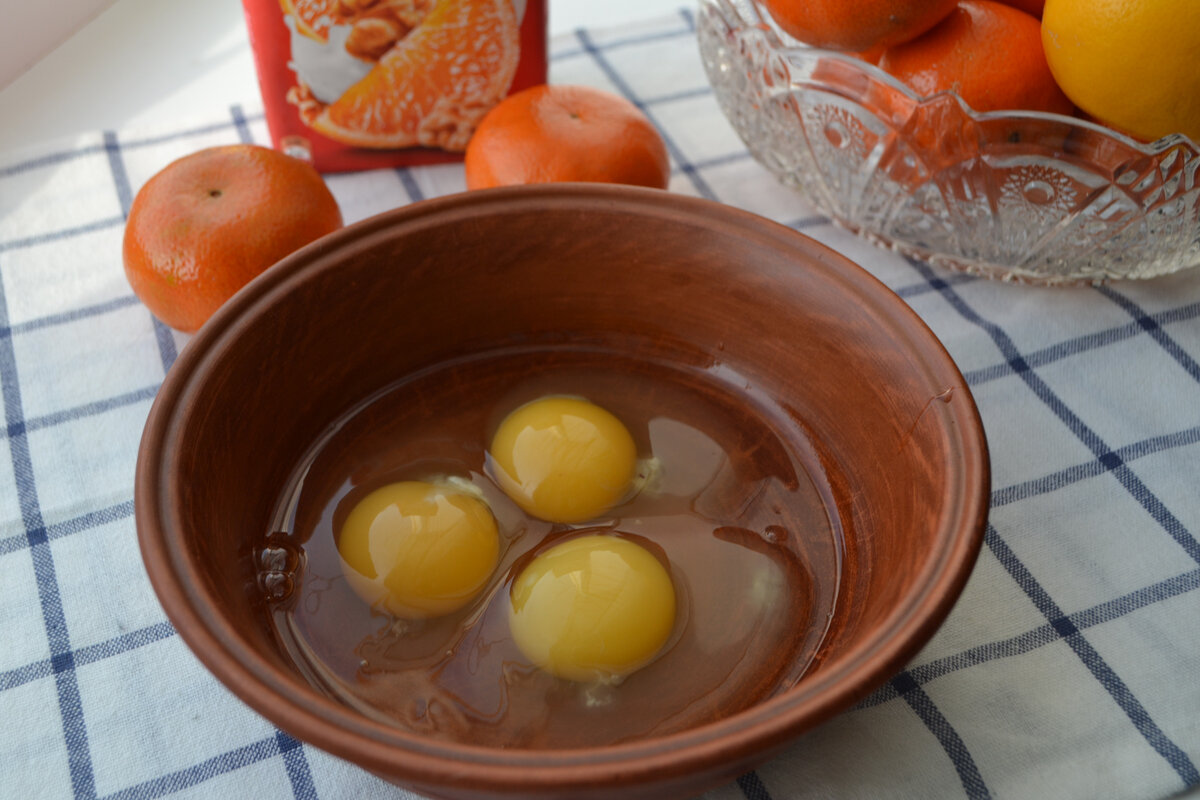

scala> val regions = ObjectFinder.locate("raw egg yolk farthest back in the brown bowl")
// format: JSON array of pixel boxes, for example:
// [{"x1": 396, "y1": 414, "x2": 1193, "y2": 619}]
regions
[{"x1": 491, "y1": 397, "x2": 637, "y2": 523}]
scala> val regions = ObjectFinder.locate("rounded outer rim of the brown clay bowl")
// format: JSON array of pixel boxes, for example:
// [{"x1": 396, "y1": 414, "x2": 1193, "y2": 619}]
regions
[{"x1": 134, "y1": 184, "x2": 990, "y2": 792}]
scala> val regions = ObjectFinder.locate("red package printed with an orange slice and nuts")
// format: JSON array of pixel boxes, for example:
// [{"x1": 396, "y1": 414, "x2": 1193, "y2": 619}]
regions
[{"x1": 242, "y1": 0, "x2": 546, "y2": 172}]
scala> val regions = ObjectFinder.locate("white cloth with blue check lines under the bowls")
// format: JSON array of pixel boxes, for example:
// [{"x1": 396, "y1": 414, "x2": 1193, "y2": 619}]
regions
[{"x1": 0, "y1": 11, "x2": 1200, "y2": 800}]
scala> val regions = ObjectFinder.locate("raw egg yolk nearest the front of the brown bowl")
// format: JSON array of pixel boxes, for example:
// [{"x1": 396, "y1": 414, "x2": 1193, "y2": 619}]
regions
[{"x1": 509, "y1": 535, "x2": 676, "y2": 681}]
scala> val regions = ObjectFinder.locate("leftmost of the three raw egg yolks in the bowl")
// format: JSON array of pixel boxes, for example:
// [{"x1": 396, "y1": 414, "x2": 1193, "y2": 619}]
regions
[{"x1": 337, "y1": 481, "x2": 500, "y2": 619}]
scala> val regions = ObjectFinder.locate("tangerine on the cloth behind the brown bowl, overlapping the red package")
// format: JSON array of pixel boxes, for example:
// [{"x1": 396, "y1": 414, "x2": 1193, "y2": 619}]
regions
[{"x1": 466, "y1": 85, "x2": 671, "y2": 188}]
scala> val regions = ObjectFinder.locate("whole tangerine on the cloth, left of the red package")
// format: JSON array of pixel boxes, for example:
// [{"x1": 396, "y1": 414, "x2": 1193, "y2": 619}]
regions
[{"x1": 122, "y1": 144, "x2": 342, "y2": 332}]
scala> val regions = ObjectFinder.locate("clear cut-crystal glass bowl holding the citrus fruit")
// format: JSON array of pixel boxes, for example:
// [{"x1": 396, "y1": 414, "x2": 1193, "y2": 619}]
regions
[{"x1": 697, "y1": 0, "x2": 1200, "y2": 284}]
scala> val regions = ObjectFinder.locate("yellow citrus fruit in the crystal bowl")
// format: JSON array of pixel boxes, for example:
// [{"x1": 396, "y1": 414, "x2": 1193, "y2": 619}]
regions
[{"x1": 1042, "y1": 0, "x2": 1200, "y2": 143}]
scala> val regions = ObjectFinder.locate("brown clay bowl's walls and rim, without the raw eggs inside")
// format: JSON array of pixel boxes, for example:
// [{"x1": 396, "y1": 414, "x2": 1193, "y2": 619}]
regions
[{"x1": 136, "y1": 185, "x2": 989, "y2": 798}]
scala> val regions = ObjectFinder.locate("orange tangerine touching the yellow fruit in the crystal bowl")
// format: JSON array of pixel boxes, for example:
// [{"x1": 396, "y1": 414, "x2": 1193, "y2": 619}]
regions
[{"x1": 878, "y1": 0, "x2": 1074, "y2": 114}]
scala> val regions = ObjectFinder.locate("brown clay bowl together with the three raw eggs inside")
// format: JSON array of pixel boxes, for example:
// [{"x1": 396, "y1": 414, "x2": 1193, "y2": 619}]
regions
[{"x1": 136, "y1": 185, "x2": 989, "y2": 798}]
